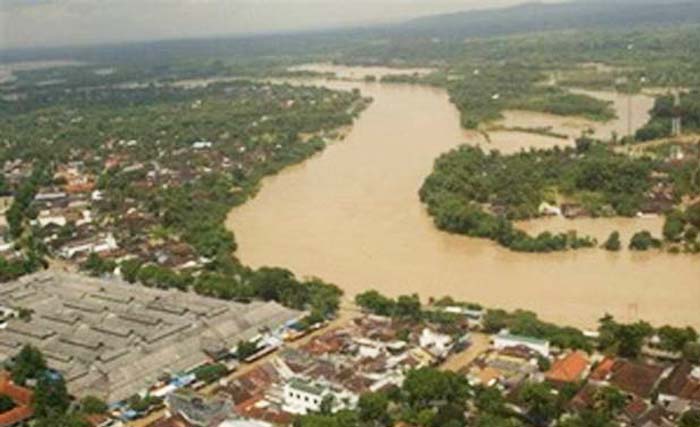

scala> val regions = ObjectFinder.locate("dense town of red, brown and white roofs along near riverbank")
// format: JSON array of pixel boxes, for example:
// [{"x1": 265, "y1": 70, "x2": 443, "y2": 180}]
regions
[{"x1": 120, "y1": 296, "x2": 700, "y2": 427}]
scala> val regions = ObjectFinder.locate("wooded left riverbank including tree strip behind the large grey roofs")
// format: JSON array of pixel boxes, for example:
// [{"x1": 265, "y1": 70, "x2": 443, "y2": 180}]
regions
[{"x1": 0, "y1": 76, "x2": 371, "y2": 325}]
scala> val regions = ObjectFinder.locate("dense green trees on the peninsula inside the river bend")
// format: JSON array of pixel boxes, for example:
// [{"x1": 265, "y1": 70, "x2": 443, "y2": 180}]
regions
[{"x1": 420, "y1": 139, "x2": 654, "y2": 252}]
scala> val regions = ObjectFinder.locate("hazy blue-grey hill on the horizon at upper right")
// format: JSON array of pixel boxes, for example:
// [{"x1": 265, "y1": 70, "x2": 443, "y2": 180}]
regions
[{"x1": 402, "y1": 0, "x2": 700, "y2": 38}]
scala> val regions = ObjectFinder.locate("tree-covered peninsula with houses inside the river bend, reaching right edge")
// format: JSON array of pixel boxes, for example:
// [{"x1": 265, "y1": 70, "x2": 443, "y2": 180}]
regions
[{"x1": 419, "y1": 136, "x2": 700, "y2": 253}]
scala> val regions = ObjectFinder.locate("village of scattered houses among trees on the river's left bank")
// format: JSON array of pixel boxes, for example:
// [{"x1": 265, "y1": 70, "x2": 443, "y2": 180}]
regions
[{"x1": 0, "y1": 83, "x2": 369, "y2": 279}]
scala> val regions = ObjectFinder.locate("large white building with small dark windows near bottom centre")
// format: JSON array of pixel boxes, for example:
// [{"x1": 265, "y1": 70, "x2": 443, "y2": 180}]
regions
[{"x1": 283, "y1": 377, "x2": 358, "y2": 415}]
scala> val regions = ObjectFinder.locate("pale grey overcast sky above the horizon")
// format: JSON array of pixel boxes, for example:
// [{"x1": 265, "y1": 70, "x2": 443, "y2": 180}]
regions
[{"x1": 0, "y1": 0, "x2": 544, "y2": 49}]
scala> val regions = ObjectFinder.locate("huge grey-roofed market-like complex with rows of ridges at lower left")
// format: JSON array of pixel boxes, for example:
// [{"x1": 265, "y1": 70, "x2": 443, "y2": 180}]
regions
[{"x1": 0, "y1": 271, "x2": 301, "y2": 402}]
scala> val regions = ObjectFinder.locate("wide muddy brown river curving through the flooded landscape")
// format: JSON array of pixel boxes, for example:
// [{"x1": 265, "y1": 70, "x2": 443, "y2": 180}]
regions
[{"x1": 227, "y1": 66, "x2": 700, "y2": 328}]
